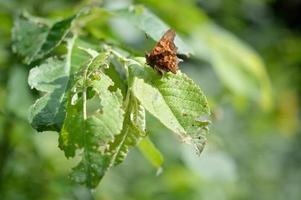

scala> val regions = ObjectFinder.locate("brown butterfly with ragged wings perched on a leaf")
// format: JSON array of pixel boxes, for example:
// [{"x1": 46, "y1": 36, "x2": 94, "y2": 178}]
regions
[{"x1": 145, "y1": 29, "x2": 179, "y2": 75}]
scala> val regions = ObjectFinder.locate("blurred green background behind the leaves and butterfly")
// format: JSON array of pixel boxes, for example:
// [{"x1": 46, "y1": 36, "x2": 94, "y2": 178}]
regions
[{"x1": 0, "y1": 0, "x2": 301, "y2": 200}]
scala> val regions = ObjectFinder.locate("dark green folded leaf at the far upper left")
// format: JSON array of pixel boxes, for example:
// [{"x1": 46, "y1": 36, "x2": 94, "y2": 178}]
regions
[{"x1": 12, "y1": 14, "x2": 77, "y2": 64}]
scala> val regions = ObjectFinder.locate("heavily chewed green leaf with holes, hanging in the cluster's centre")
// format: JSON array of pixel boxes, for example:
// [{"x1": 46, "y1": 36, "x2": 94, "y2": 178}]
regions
[{"x1": 60, "y1": 65, "x2": 123, "y2": 157}]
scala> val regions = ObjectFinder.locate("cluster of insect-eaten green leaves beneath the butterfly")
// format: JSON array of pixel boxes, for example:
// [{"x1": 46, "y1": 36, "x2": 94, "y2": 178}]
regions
[{"x1": 13, "y1": 7, "x2": 210, "y2": 188}]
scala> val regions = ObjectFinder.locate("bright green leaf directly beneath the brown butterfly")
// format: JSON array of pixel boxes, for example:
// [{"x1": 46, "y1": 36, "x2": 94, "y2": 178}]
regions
[{"x1": 130, "y1": 59, "x2": 210, "y2": 151}]
